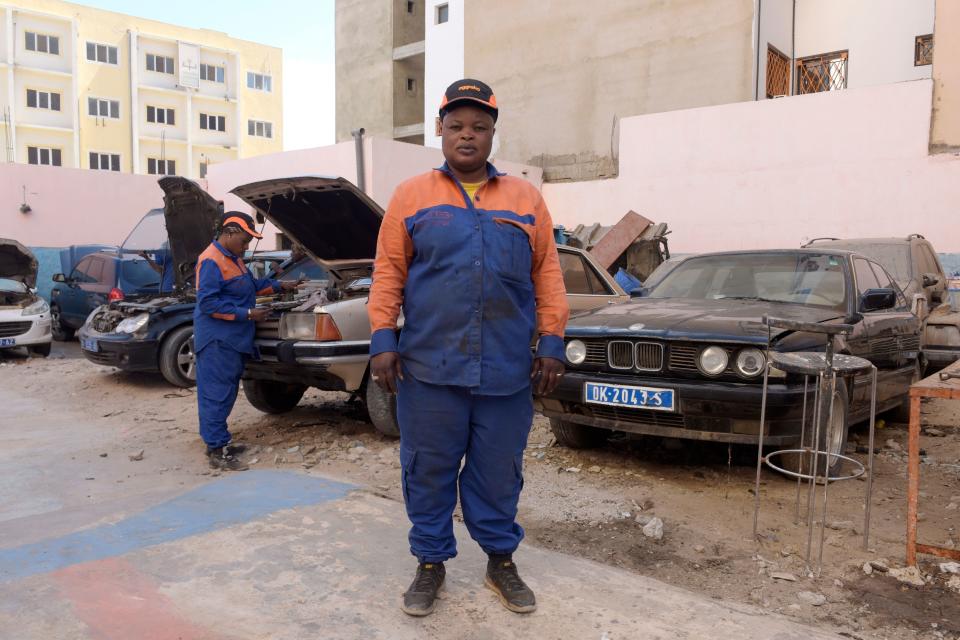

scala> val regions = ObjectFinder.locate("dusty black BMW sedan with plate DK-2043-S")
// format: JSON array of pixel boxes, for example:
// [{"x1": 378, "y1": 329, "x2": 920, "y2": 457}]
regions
[{"x1": 537, "y1": 250, "x2": 920, "y2": 476}]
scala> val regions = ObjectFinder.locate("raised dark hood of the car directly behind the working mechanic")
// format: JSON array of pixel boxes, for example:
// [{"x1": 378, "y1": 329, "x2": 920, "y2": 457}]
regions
[{"x1": 159, "y1": 176, "x2": 223, "y2": 289}]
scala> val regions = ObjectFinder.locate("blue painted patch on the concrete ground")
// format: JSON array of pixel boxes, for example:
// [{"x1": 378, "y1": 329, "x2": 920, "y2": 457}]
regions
[{"x1": 0, "y1": 471, "x2": 356, "y2": 582}]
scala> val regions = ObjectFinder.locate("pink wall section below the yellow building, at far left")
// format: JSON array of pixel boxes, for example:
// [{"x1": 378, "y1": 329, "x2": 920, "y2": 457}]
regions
[{"x1": 0, "y1": 163, "x2": 163, "y2": 247}]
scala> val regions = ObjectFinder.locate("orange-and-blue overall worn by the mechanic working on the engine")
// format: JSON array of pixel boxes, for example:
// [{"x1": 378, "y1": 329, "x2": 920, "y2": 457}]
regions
[{"x1": 193, "y1": 241, "x2": 280, "y2": 450}]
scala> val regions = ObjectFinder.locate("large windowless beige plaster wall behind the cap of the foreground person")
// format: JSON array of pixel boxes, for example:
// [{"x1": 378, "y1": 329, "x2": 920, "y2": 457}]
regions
[{"x1": 464, "y1": 0, "x2": 754, "y2": 180}]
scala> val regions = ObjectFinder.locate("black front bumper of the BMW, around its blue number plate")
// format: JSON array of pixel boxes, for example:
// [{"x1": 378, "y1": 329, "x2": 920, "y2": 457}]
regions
[{"x1": 535, "y1": 370, "x2": 813, "y2": 445}]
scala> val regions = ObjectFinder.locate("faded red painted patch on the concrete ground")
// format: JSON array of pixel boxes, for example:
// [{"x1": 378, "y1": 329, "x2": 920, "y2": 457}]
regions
[{"x1": 51, "y1": 558, "x2": 223, "y2": 640}]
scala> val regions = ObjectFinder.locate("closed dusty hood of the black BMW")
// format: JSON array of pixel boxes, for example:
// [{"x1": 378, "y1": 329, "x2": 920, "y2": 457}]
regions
[{"x1": 566, "y1": 298, "x2": 842, "y2": 344}]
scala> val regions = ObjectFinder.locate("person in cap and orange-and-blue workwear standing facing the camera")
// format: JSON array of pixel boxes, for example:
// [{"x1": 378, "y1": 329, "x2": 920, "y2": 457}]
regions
[{"x1": 369, "y1": 79, "x2": 569, "y2": 616}]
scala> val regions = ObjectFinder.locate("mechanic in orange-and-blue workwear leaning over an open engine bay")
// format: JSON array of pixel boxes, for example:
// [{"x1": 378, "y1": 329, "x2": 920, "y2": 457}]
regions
[{"x1": 193, "y1": 211, "x2": 298, "y2": 471}]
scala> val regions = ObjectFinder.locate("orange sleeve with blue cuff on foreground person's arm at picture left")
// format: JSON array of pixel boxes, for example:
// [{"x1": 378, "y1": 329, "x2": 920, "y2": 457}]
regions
[{"x1": 367, "y1": 188, "x2": 413, "y2": 357}]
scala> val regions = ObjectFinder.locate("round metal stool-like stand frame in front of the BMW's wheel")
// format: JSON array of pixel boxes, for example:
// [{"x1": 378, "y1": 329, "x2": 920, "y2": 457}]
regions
[{"x1": 753, "y1": 318, "x2": 877, "y2": 576}]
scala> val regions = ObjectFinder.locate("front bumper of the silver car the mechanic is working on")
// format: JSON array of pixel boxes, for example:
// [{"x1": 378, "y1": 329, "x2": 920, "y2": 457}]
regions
[{"x1": 243, "y1": 339, "x2": 370, "y2": 391}]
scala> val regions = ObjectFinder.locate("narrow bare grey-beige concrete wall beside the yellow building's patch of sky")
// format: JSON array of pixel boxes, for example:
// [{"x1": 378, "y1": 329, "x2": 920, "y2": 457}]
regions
[{"x1": 334, "y1": 0, "x2": 395, "y2": 142}]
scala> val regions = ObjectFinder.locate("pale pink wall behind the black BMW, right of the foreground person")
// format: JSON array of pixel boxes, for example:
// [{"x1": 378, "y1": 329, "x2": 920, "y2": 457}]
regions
[{"x1": 543, "y1": 80, "x2": 960, "y2": 253}]
